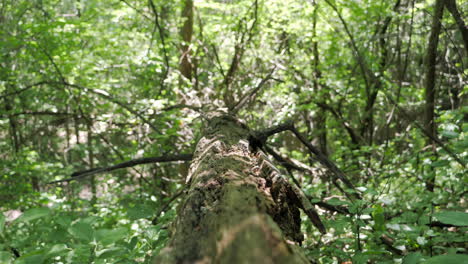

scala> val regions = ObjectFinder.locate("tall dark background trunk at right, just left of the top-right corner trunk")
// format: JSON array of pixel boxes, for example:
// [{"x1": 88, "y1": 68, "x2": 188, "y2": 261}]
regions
[{"x1": 424, "y1": 0, "x2": 444, "y2": 191}]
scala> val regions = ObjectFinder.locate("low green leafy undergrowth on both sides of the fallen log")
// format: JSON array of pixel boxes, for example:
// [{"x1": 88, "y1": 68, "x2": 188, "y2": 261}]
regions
[{"x1": 0, "y1": 121, "x2": 468, "y2": 264}]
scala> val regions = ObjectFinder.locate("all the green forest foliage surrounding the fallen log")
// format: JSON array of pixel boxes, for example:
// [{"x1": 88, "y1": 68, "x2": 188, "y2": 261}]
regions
[{"x1": 0, "y1": 0, "x2": 468, "y2": 263}]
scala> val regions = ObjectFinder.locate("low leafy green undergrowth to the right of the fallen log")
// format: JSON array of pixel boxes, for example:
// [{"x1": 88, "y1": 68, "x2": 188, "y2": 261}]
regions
[{"x1": 303, "y1": 124, "x2": 468, "y2": 264}]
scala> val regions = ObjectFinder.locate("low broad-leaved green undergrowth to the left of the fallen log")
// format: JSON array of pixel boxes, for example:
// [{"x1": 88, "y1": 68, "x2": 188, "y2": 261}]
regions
[{"x1": 0, "y1": 193, "x2": 175, "y2": 264}]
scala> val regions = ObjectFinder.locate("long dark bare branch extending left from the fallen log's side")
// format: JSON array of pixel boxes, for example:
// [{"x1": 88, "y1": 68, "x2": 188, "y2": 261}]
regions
[{"x1": 48, "y1": 154, "x2": 193, "y2": 184}]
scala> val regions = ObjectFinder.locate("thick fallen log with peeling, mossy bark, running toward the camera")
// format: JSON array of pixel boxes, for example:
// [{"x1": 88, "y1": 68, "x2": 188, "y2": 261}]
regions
[{"x1": 155, "y1": 112, "x2": 309, "y2": 263}]
